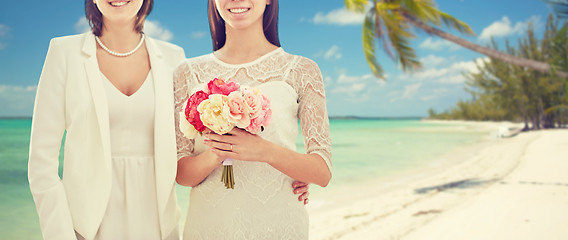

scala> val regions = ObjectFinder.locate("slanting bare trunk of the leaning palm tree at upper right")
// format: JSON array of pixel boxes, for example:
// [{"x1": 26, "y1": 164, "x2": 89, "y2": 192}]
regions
[{"x1": 404, "y1": 14, "x2": 568, "y2": 78}]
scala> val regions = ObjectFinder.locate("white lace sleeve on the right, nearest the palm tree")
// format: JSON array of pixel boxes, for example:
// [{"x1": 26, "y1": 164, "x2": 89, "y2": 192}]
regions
[{"x1": 292, "y1": 57, "x2": 332, "y2": 172}]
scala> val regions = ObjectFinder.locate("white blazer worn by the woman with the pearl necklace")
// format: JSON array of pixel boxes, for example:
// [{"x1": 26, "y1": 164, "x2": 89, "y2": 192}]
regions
[{"x1": 28, "y1": 33, "x2": 185, "y2": 240}]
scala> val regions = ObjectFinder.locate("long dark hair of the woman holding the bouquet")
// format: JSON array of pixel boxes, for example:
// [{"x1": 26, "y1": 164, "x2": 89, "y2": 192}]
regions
[{"x1": 208, "y1": 0, "x2": 280, "y2": 51}]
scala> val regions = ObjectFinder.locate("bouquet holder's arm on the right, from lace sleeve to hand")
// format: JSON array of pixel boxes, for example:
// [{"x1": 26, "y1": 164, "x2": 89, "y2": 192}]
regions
[{"x1": 205, "y1": 58, "x2": 331, "y2": 187}]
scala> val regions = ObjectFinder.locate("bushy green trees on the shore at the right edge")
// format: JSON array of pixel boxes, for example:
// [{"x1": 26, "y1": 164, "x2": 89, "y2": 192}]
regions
[{"x1": 428, "y1": 15, "x2": 568, "y2": 129}]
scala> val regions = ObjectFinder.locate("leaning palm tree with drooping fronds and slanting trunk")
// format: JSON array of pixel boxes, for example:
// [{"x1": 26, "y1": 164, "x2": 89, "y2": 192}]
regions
[{"x1": 344, "y1": 0, "x2": 568, "y2": 79}]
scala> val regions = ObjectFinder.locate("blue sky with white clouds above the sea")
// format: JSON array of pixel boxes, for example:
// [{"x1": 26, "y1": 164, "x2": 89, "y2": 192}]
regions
[{"x1": 0, "y1": 0, "x2": 552, "y2": 117}]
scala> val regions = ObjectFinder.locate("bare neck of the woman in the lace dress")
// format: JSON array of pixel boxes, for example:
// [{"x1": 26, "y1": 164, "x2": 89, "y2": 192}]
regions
[{"x1": 218, "y1": 21, "x2": 277, "y2": 63}]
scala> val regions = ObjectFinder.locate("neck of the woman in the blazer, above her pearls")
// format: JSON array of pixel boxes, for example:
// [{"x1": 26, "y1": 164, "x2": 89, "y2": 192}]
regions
[{"x1": 99, "y1": 19, "x2": 140, "y2": 52}]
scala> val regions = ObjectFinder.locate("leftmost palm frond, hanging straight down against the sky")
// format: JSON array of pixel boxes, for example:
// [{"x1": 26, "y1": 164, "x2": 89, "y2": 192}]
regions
[{"x1": 362, "y1": 12, "x2": 385, "y2": 80}]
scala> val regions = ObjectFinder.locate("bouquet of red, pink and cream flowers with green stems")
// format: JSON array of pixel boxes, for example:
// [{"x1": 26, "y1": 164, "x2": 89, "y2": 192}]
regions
[{"x1": 179, "y1": 78, "x2": 272, "y2": 189}]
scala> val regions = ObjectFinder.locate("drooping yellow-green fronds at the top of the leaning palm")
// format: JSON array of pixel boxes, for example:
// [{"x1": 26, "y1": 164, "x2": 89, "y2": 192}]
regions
[{"x1": 344, "y1": 0, "x2": 473, "y2": 80}]
